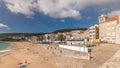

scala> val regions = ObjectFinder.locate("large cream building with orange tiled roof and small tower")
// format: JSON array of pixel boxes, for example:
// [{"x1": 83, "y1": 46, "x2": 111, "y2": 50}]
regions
[{"x1": 99, "y1": 14, "x2": 120, "y2": 43}]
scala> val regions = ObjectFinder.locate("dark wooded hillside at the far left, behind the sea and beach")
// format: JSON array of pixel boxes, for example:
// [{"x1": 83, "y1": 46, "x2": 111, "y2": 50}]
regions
[{"x1": 0, "y1": 33, "x2": 45, "y2": 41}]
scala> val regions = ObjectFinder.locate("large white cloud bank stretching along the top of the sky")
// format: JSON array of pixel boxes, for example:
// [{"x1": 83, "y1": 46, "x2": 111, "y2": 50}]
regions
[{"x1": 3, "y1": 0, "x2": 120, "y2": 18}]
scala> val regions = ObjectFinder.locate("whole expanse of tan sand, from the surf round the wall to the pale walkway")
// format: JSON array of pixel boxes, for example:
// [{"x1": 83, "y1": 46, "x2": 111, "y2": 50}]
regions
[{"x1": 0, "y1": 42, "x2": 120, "y2": 68}]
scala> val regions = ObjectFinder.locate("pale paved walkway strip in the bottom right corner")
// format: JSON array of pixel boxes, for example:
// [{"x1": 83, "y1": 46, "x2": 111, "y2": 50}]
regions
[{"x1": 99, "y1": 50, "x2": 120, "y2": 68}]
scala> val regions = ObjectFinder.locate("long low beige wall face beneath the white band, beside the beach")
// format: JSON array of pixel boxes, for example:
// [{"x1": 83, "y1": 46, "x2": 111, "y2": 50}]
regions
[{"x1": 47, "y1": 45, "x2": 90, "y2": 60}]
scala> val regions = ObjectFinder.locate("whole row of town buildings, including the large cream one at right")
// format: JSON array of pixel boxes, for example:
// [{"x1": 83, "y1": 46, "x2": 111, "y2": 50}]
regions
[{"x1": 27, "y1": 14, "x2": 120, "y2": 45}]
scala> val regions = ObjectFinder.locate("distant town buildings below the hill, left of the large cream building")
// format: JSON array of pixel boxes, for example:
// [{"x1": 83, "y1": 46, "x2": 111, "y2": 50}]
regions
[{"x1": 29, "y1": 24, "x2": 99, "y2": 45}]
